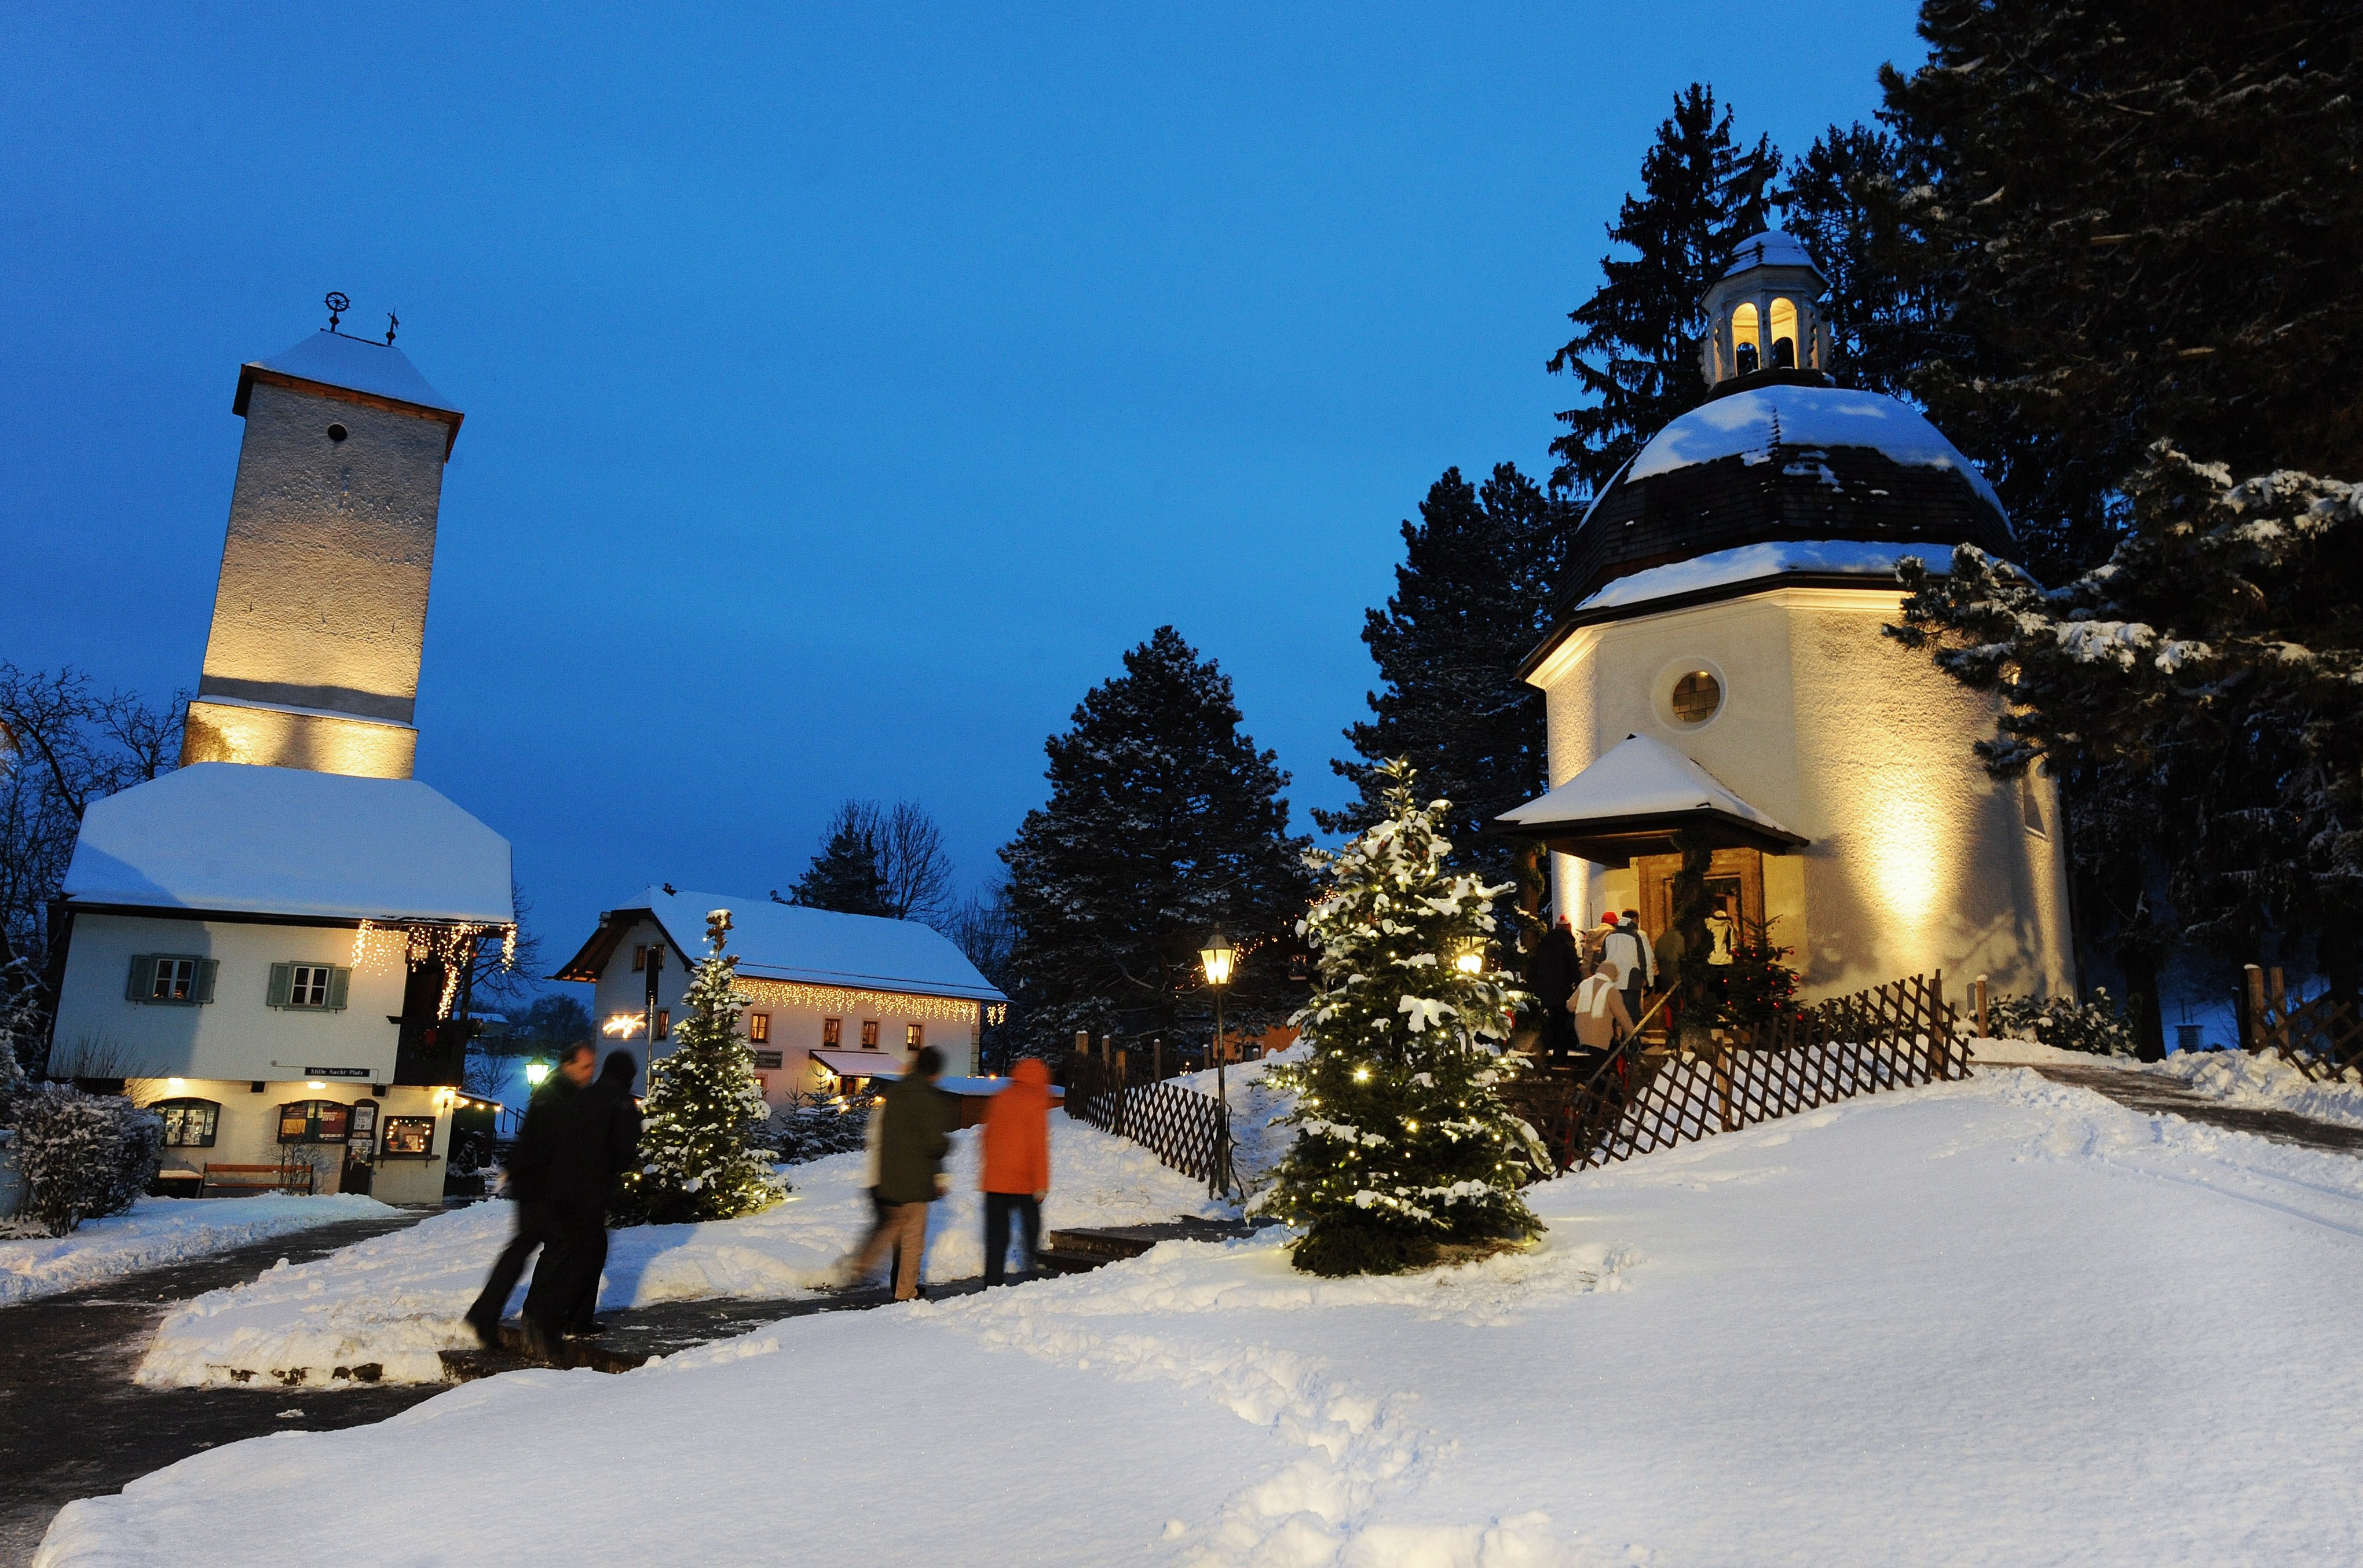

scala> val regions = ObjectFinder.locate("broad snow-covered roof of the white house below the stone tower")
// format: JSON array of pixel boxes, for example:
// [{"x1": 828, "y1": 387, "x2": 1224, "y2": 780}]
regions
[{"x1": 64, "y1": 763, "x2": 518, "y2": 926}]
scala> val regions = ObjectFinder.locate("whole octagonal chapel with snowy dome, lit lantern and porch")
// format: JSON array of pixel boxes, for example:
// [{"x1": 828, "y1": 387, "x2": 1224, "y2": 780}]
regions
[{"x1": 1503, "y1": 232, "x2": 2075, "y2": 997}]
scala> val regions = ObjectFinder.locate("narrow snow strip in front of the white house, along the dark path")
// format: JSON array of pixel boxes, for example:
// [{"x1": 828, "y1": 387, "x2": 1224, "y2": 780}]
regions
[{"x1": 0, "y1": 1193, "x2": 392, "y2": 1306}]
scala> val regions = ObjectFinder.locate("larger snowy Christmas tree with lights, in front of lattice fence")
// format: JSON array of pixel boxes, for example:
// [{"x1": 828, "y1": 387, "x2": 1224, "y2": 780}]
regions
[{"x1": 1260, "y1": 763, "x2": 1550, "y2": 1275}]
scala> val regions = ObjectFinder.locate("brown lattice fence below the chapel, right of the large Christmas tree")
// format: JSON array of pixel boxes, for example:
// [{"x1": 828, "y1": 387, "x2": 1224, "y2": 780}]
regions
[{"x1": 1503, "y1": 975, "x2": 1969, "y2": 1171}]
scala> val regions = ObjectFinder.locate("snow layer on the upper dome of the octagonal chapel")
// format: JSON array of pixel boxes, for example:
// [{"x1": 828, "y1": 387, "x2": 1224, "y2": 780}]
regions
[{"x1": 1623, "y1": 385, "x2": 2002, "y2": 512}]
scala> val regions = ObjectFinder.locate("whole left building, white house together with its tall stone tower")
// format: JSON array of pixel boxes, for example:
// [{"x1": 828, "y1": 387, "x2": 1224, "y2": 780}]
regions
[{"x1": 50, "y1": 326, "x2": 515, "y2": 1202}]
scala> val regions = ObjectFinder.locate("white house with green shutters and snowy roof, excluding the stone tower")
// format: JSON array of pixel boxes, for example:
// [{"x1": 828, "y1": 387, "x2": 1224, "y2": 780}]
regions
[{"x1": 50, "y1": 763, "x2": 515, "y2": 1202}]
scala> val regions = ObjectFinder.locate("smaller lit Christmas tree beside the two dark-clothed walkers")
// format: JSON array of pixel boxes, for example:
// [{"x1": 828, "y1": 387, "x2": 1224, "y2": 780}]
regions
[{"x1": 614, "y1": 909, "x2": 780, "y2": 1226}]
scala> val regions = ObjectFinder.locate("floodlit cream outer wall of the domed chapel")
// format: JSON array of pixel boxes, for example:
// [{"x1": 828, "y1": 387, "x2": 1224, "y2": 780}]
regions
[{"x1": 1534, "y1": 588, "x2": 2075, "y2": 997}]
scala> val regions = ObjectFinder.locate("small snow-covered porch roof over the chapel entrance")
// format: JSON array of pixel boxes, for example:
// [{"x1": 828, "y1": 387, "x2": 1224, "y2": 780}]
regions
[{"x1": 1494, "y1": 734, "x2": 1808, "y2": 867}]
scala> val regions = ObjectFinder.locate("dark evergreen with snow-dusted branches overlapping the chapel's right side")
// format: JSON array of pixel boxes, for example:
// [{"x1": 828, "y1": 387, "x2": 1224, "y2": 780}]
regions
[{"x1": 1890, "y1": 444, "x2": 2363, "y2": 1053}]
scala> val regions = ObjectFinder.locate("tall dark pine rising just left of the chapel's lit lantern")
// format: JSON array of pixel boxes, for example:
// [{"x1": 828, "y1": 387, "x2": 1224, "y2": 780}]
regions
[{"x1": 1550, "y1": 83, "x2": 1779, "y2": 496}]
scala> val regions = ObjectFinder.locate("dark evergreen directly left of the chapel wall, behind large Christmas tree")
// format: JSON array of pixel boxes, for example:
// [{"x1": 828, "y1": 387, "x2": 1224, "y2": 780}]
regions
[{"x1": 1314, "y1": 463, "x2": 1567, "y2": 881}]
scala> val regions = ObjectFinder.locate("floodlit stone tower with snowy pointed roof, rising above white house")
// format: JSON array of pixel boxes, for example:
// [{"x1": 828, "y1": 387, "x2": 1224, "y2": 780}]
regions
[{"x1": 182, "y1": 331, "x2": 461, "y2": 779}]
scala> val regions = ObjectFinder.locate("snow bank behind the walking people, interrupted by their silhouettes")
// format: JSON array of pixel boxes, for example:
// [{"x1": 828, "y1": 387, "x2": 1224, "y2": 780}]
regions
[{"x1": 137, "y1": 1115, "x2": 1219, "y2": 1386}]
